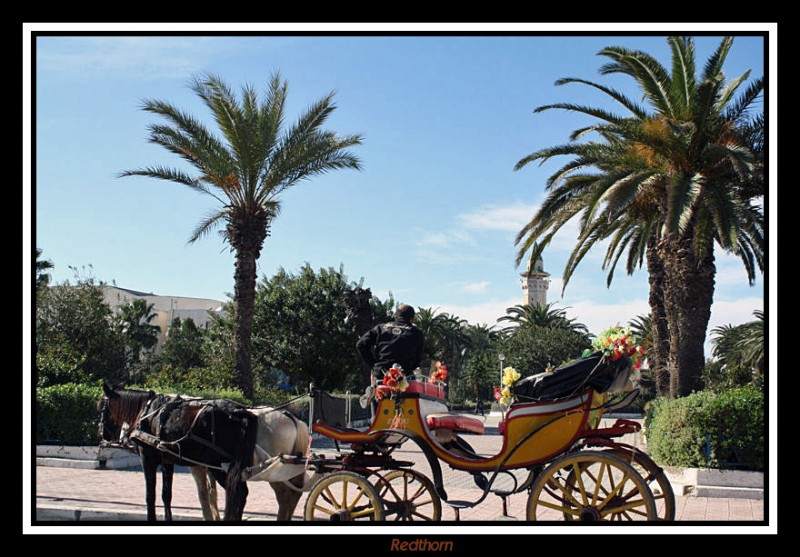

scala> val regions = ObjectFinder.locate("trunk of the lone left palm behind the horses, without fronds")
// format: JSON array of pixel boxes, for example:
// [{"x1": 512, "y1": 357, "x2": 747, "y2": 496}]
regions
[{"x1": 227, "y1": 208, "x2": 270, "y2": 400}]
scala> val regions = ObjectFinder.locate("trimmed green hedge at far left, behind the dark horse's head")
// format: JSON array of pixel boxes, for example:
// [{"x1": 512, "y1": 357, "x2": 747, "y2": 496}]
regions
[{"x1": 35, "y1": 383, "x2": 103, "y2": 446}]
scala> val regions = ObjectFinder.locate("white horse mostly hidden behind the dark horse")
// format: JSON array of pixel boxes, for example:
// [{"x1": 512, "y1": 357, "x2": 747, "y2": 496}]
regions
[{"x1": 190, "y1": 406, "x2": 311, "y2": 521}]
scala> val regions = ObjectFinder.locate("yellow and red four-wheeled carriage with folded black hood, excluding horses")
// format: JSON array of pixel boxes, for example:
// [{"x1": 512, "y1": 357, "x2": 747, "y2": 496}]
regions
[{"x1": 290, "y1": 353, "x2": 675, "y2": 522}]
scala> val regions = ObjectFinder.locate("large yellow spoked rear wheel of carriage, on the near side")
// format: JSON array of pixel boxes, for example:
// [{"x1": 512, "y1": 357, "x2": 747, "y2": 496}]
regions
[{"x1": 527, "y1": 451, "x2": 656, "y2": 522}]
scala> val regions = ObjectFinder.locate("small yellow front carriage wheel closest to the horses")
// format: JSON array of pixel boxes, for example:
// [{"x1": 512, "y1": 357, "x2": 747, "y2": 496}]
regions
[{"x1": 305, "y1": 472, "x2": 384, "y2": 522}]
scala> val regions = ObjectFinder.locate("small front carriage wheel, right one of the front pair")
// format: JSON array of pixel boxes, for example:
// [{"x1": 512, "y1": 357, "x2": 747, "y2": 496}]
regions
[{"x1": 375, "y1": 470, "x2": 442, "y2": 522}]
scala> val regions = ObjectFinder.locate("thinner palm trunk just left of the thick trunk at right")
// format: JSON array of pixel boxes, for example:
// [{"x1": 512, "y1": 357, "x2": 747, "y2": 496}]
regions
[{"x1": 647, "y1": 240, "x2": 670, "y2": 396}]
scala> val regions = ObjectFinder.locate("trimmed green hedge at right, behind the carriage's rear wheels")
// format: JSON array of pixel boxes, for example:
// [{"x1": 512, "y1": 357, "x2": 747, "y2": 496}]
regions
[{"x1": 645, "y1": 387, "x2": 765, "y2": 471}]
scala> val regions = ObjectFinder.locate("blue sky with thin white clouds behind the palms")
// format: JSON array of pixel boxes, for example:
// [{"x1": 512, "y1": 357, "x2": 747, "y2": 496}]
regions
[{"x1": 25, "y1": 25, "x2": 765, "y2": 356}]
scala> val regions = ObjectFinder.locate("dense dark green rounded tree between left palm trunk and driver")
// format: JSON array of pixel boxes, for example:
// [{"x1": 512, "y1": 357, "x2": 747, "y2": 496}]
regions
[{"x1": 253, "y1": 264, "x2": 363, "y2": 390}]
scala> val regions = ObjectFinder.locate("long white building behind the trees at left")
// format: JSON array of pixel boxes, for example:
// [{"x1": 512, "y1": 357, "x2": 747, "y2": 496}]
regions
[{"x1": 103, "y1": 285, "x2": 224, "y2": 351}]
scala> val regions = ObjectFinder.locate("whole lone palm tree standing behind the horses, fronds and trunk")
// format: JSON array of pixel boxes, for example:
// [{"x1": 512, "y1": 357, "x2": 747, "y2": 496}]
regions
[{"x1": 121, "y1": 74, "x2": 361, "y2": 399}]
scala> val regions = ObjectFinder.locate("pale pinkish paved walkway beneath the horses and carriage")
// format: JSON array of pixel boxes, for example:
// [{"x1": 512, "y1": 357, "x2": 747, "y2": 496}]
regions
[{"x1": 31, "y1": 412, "x2": 774, "y2": 533}]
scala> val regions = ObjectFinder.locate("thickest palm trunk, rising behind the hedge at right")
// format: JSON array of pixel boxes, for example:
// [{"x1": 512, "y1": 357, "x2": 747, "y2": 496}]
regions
[{"x1": 659, "y1": 235, "x2": 716, "y2": 398}]
